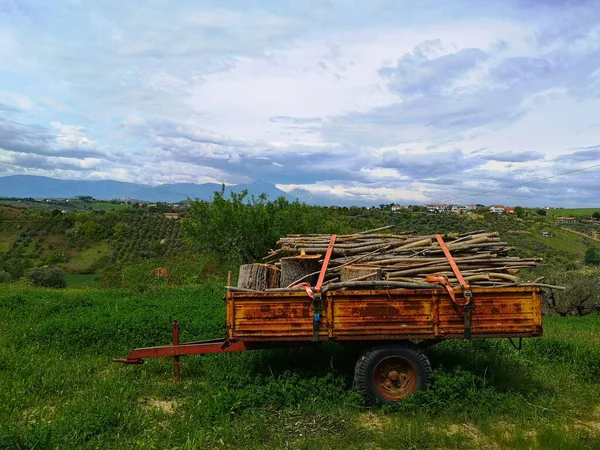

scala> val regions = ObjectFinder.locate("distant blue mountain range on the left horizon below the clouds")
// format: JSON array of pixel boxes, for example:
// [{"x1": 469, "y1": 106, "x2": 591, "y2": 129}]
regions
[{"x1": 0, "y1": 175, "x2": 298, "y2": 202}]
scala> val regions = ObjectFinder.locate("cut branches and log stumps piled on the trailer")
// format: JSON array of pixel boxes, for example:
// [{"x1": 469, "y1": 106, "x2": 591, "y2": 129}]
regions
[{"x1": 233, "y1": 226, "x2": 552, "y2": 291}]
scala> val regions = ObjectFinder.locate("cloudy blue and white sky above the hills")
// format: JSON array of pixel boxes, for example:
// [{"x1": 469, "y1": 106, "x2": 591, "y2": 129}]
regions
[{"x1": 0, "y1": 0, "x2": 600, "y2": 206}]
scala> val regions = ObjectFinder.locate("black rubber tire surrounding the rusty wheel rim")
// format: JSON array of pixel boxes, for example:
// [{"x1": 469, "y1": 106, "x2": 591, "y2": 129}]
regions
[{"x1": 354, "y1": 342, "x2": 431, "y2": 406}]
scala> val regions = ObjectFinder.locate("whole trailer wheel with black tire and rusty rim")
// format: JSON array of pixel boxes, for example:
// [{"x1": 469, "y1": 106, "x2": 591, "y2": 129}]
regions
[{"x1": 354, "y1": 343, "x2": 431, "y2": 405}]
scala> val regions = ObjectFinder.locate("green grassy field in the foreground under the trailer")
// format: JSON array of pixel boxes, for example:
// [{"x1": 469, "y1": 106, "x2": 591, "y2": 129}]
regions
[{"x1": 0, "y1": 284, "x2": 600, "y2": 449}]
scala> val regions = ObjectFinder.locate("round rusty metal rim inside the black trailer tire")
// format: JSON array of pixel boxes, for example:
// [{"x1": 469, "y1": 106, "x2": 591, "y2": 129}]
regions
[{"x1": 373, "y1": 356, "x2": 418, "y2": 401}]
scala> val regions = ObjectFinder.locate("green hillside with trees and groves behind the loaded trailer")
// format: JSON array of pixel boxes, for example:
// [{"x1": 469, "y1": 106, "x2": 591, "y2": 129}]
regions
[{"x1": 0, "y1": 190, "x2": 600, "y2": 304}]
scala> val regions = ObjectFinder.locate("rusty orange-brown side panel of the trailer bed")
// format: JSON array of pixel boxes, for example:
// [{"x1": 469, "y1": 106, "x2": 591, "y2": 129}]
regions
[{"x1": 226, "y1": 287, "x2": 542, "y2": 341}]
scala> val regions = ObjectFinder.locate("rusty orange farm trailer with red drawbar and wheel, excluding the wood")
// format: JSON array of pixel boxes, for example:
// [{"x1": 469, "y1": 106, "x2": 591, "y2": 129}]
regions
[{"x1": 115, "y1": 286, "x2": 542, "y2": 404}]
